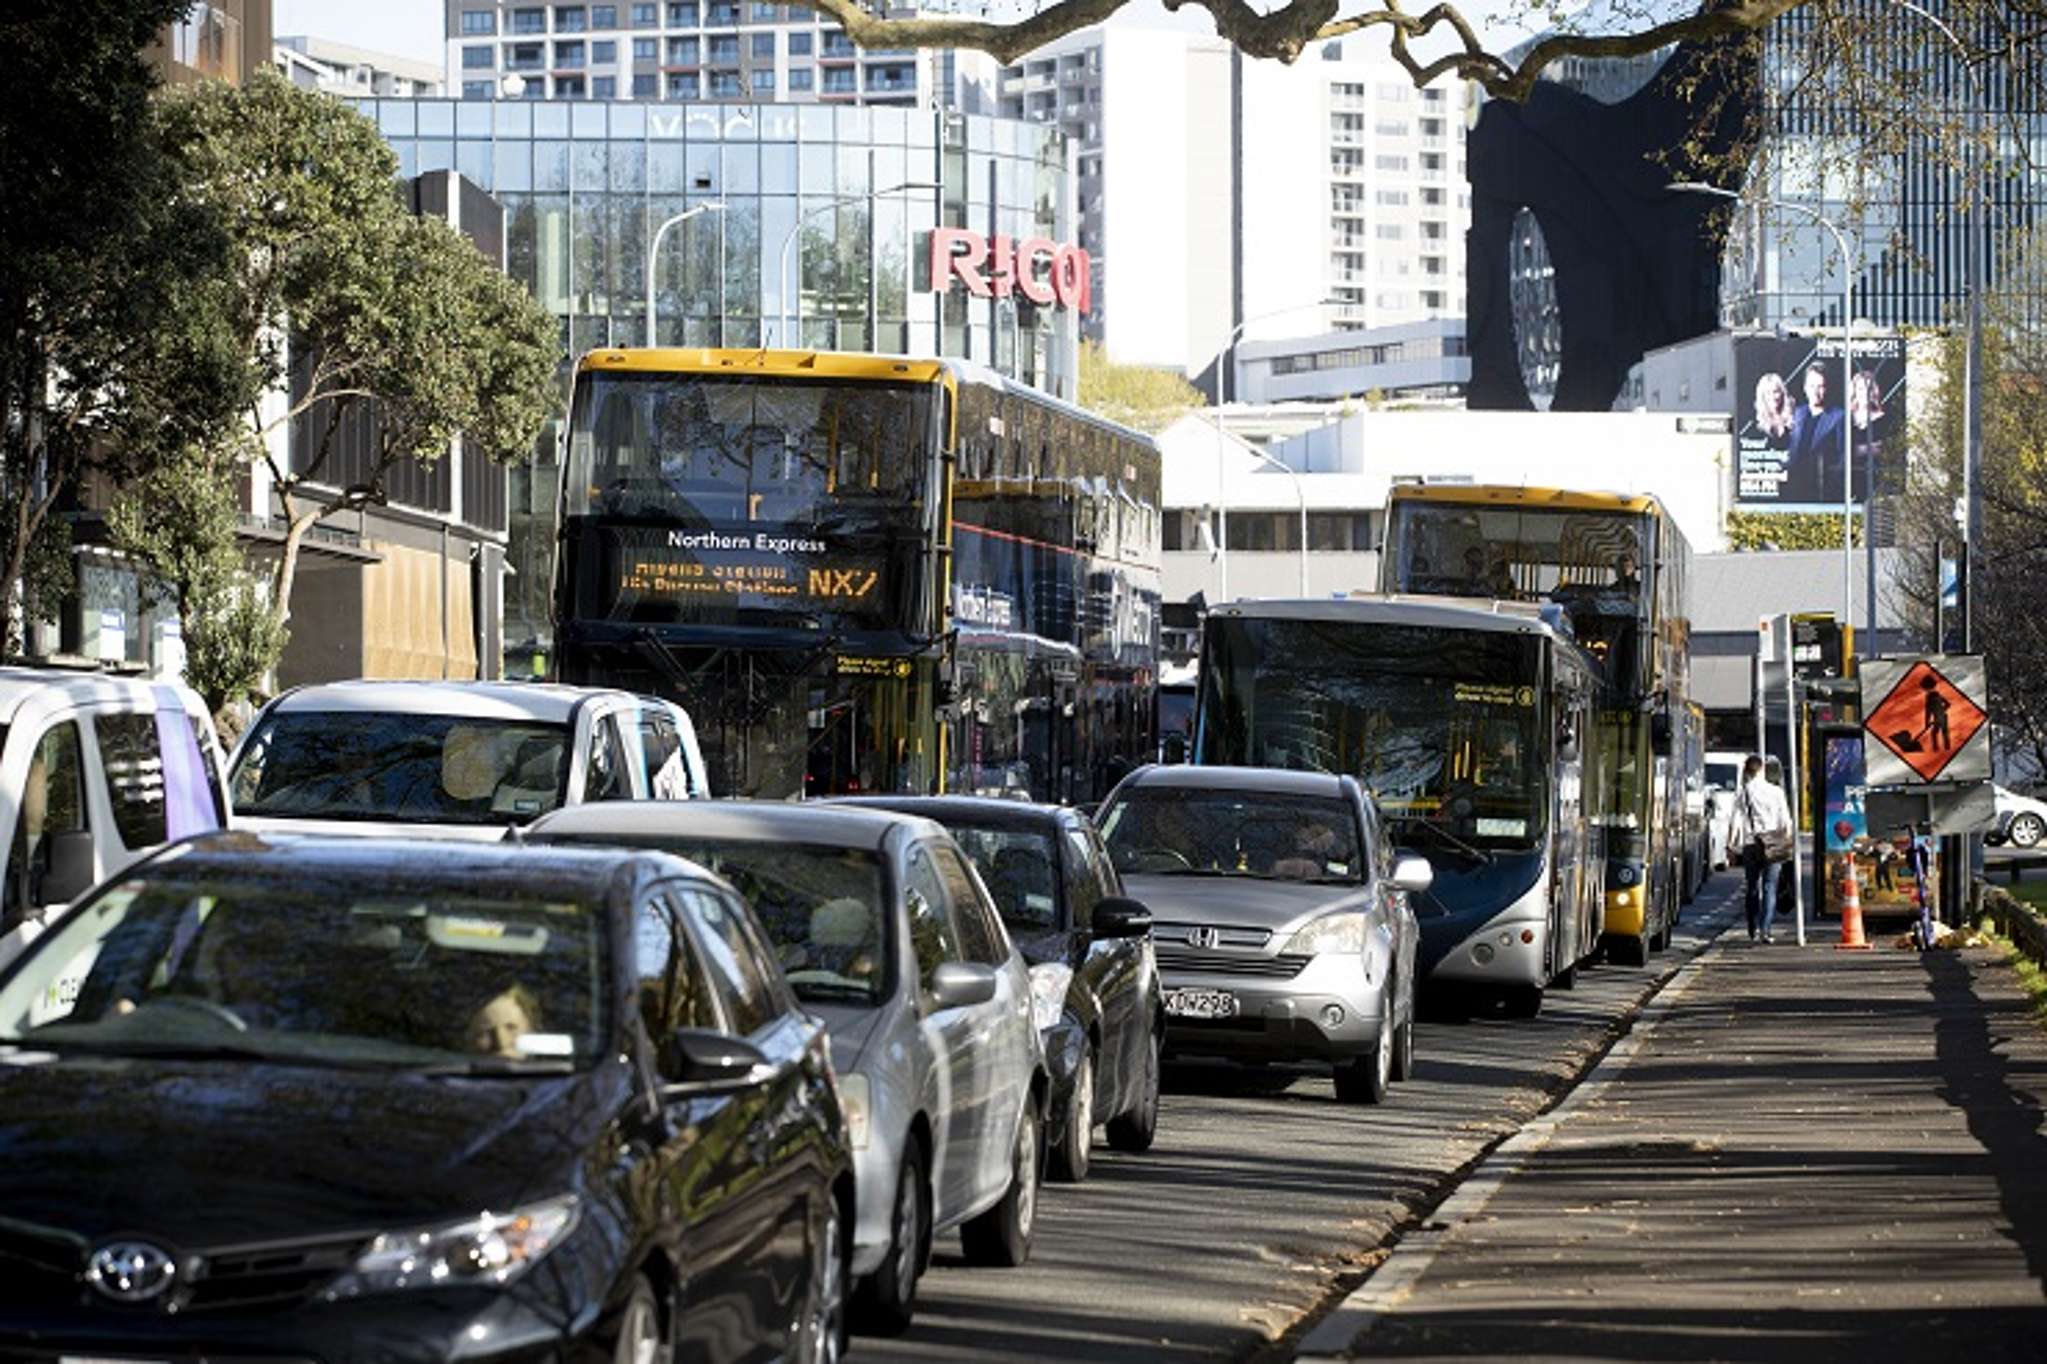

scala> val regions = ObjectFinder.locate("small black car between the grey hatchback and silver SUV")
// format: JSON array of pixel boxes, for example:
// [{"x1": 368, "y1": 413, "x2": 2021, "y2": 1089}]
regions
[{"x1": 831, "y1": 797, "x2": 1165, "y2": 1182}]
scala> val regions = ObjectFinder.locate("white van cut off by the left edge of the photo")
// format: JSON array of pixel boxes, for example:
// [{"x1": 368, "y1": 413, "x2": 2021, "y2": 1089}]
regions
[{"x1": 0, "y1": 668, "x2": 227, "y2": 965}]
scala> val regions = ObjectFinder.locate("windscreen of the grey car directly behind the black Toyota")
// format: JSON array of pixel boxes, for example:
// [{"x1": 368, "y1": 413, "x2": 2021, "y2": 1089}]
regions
[{"x1": 563, "y1": 834, "x2": 892, "y2": 1006}]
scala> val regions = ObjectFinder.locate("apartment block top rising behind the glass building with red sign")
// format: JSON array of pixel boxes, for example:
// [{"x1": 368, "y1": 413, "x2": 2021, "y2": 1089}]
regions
[{"x1": 446, "y1": 0, "x2": 995, "y2": 113}]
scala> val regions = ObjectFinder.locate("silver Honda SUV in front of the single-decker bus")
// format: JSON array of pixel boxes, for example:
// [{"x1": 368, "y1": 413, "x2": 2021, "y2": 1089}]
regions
[{"x1": 1101, "y1": 766, "x2": 1431, "y2": 1104}]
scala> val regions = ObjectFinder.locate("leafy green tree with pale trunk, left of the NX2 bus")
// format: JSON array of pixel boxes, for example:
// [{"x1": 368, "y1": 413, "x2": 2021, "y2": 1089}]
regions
[{"x1": 149, "y1": 72, "x2": 559, "y2": 639}]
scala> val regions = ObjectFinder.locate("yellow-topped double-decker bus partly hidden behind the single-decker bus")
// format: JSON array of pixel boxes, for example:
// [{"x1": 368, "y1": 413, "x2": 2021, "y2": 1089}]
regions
[{"x1": 1380, "y1": 483, "x2": 1691, "y2": 965}]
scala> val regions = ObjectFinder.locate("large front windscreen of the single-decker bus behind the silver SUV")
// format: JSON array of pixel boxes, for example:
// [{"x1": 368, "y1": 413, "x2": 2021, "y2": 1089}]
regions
[{"x1": 1195, "y1": 616, "x2": 1550, "y2": 848}]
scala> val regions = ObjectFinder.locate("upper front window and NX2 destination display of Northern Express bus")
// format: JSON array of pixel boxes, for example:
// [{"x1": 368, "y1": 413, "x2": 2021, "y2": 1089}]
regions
[{"x1": 563, "y1": 371, "x2": 940, "y2": 629}]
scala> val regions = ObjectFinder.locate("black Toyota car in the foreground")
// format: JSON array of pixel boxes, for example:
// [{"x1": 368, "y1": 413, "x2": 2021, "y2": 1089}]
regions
[{"x1": 0, "y1": 834, "x2": 854, "y2": 1362}]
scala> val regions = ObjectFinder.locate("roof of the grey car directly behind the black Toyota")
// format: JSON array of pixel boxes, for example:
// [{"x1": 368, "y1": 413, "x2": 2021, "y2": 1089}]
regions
[{"x1": 526, "y1": 801, "x2": 944, "y2": 852}]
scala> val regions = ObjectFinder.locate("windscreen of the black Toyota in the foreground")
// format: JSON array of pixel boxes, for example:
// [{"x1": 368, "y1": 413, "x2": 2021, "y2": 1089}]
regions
[{"x1": 0, "y1": 877, "x2": 606, "y2": 1071}]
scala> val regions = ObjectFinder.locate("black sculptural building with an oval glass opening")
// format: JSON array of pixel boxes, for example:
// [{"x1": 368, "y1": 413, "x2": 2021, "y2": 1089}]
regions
[{"x1": 1466, "y1": 10, "x2": 1758, "y2": 412}]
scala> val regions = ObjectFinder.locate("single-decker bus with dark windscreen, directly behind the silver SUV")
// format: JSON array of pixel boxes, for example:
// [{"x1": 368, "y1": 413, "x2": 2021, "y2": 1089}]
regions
[{"x1": 1195, "y1": 598, "x2": 1603, "y2": 1016}]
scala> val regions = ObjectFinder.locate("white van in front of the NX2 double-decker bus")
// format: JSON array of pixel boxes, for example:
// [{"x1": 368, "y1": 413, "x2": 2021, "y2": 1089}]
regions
[{"x1": 227, "y1": 682, "x2": 710, "y2": 840}]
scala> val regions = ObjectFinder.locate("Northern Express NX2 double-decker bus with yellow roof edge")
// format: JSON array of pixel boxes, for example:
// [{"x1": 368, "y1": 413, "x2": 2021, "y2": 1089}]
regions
[{"x1": 555, "y1": 350, "x2": 1161, "y2": 801}]
